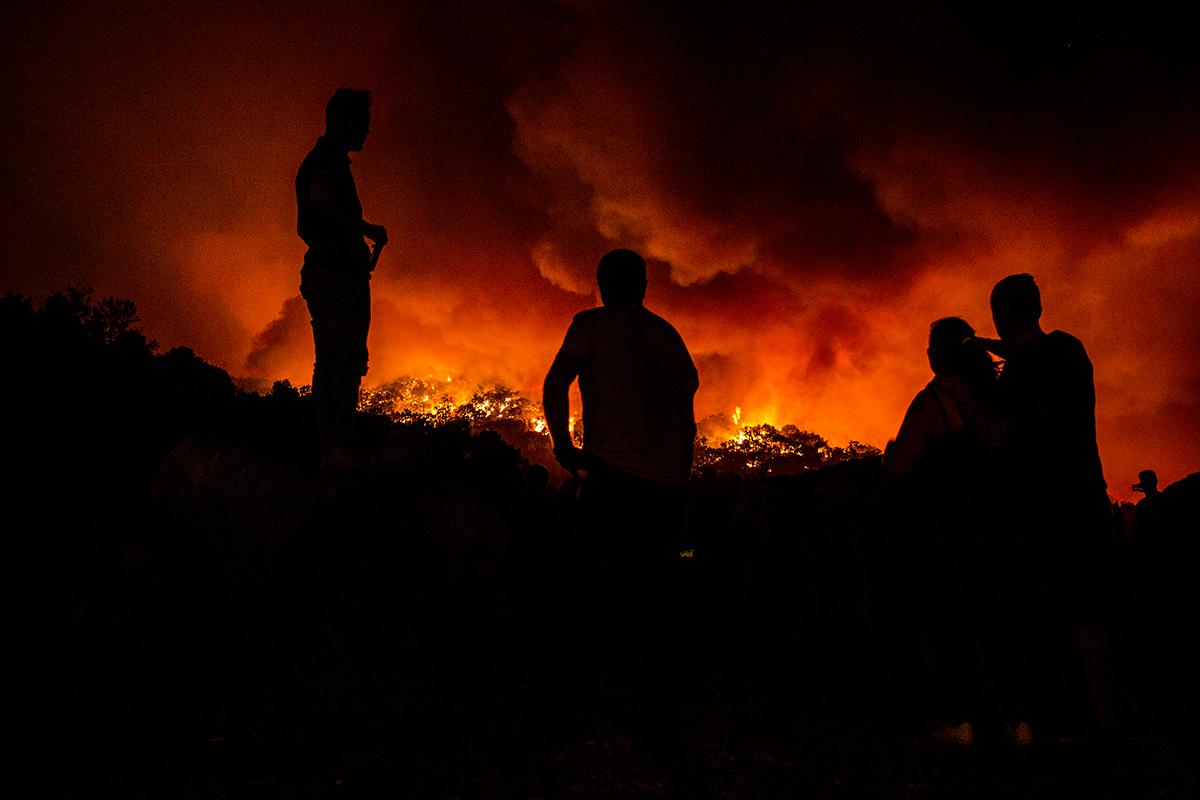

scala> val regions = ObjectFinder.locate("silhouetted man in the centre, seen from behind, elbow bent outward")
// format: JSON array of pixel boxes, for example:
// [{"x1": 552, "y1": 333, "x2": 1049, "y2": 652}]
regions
[{"x1": 542, "y1": 249, "x2": 700, "y2": 734}]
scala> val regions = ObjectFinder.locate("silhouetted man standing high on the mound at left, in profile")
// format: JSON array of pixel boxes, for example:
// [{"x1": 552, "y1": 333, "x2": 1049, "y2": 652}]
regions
[{"x1": 296, "y1": 89, "x2": 388, "y2": 469}]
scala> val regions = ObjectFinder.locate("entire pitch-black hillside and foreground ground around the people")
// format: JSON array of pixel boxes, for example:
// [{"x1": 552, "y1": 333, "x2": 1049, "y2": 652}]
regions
[{"x1": 11, "y1": 290, "x2": 1200, "y2": 800}]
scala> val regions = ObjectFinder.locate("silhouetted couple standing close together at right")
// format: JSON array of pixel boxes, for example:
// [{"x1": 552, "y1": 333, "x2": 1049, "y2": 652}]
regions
[{"x1": 884, "y1": 275, "x2": 1114, "y2": 744}]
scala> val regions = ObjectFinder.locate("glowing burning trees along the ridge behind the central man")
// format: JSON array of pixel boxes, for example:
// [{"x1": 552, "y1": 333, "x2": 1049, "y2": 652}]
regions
[{"x1": 359, "y1": 375, "x2": 880, "y2": 477}]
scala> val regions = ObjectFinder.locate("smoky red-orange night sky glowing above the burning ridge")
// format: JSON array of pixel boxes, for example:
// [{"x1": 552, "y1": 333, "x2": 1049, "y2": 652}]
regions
[{"x1": 0, "y1": 0, "x2": 1200, "y2": 499}]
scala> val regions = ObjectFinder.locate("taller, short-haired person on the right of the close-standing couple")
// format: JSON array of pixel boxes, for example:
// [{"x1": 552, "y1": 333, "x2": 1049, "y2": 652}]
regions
[{"x1": 938, "y1": 275, "x2": 1114, "y2": 735}]
